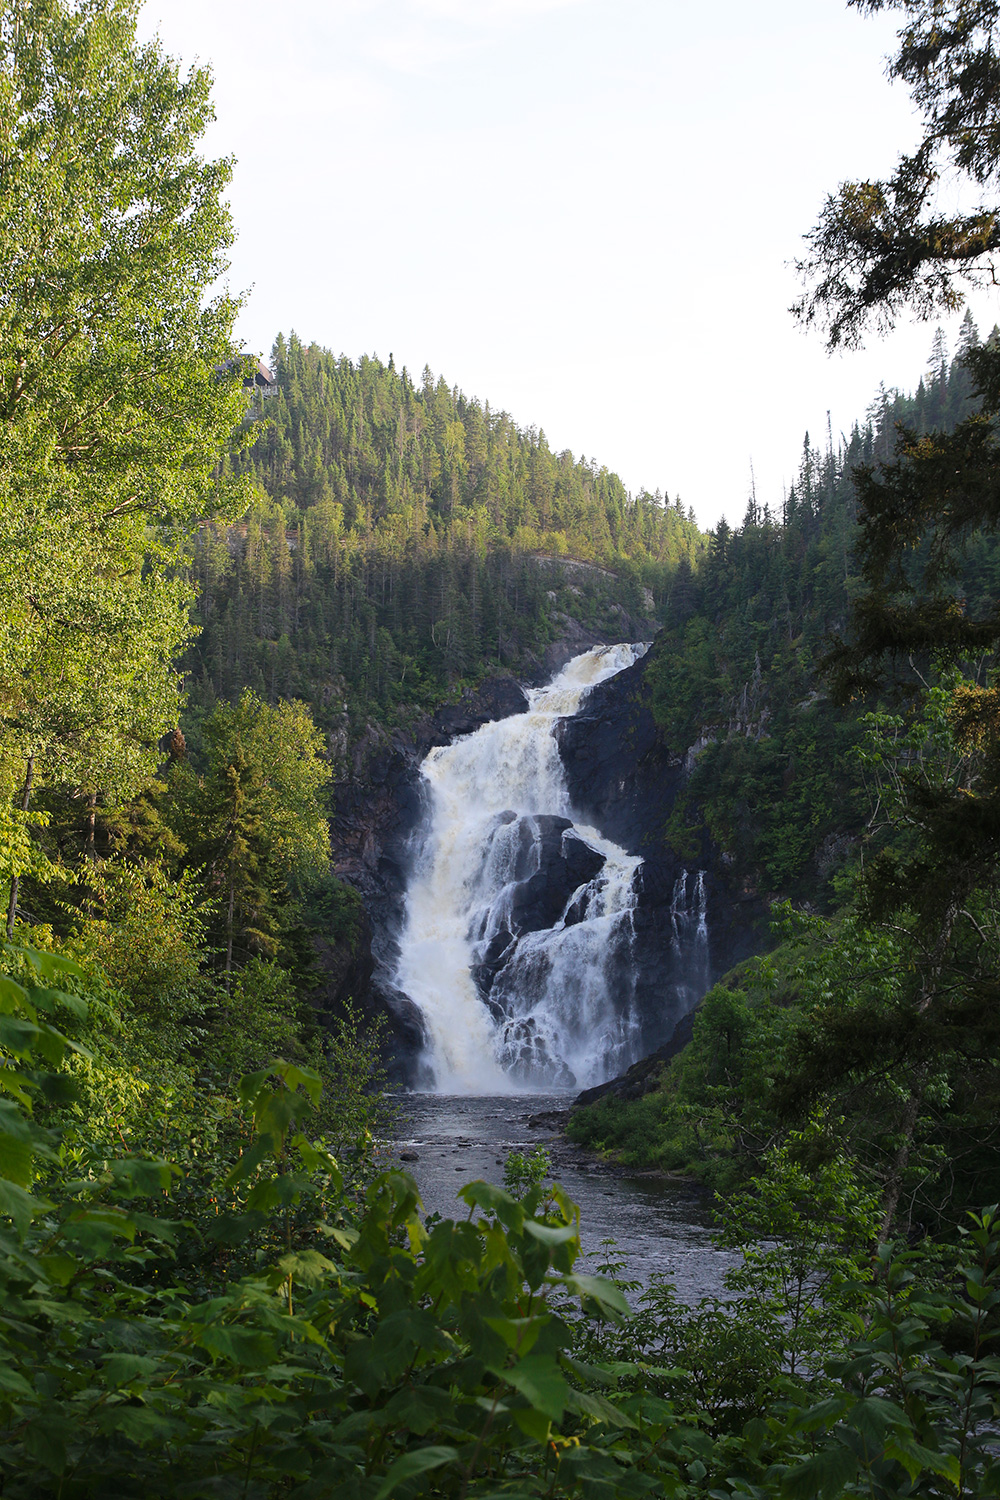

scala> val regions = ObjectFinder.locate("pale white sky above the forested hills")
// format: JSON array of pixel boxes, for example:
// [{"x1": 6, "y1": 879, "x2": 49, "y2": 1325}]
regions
[{"x1": 142, "y1": 0, "x2": 1000, "y2": 527}]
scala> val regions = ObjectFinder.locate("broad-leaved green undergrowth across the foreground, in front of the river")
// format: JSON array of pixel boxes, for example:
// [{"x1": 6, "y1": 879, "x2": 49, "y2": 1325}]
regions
[{"x1": 0, "y1": 950, "x2": 1000, "y2": 1500}]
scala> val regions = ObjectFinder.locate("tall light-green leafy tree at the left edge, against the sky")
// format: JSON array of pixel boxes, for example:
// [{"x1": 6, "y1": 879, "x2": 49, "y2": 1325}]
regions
[{"x1": 0, "y1": 0, "x2": 250, "y2": 899}]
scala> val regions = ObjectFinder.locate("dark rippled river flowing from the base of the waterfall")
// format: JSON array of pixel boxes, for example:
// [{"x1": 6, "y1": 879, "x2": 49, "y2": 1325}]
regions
[{"x1": 396, "y1": 1094, "x2": 733, "y2": 1305}]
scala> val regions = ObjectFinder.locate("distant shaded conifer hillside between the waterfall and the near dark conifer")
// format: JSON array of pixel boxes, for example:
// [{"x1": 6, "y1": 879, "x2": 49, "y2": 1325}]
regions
[{"x1": 648, "y1": 318, "x2": 1000, "y2": 902}]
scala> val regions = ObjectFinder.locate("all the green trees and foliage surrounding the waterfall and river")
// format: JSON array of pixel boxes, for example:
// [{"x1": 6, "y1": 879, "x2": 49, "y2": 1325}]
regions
[{"x1": 7, "y1": 0, "x2": 1000, "y2": 1500}]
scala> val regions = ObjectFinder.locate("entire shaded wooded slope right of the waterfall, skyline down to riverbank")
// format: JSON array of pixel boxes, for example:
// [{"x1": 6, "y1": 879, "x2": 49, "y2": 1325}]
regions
[{"x1": 570, "y1": 304, "x2": 1000, "y2": 1233}]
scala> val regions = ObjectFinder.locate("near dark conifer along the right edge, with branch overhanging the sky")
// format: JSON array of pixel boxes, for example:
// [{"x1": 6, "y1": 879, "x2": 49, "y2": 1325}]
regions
[{"x1": 798, "y1": 0, "x2": 1000, "y2": 1235}]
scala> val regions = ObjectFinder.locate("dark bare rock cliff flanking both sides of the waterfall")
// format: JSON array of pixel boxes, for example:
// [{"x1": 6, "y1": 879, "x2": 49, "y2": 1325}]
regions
[{"x1": 321, "y1": 635, "x2": 765, "y2": 1082}]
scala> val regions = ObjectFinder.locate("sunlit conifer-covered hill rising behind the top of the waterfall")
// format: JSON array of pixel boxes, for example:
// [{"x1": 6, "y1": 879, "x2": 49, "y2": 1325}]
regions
[{"x1": 187, "y1": 336, "x2": 705, "y2": 725}]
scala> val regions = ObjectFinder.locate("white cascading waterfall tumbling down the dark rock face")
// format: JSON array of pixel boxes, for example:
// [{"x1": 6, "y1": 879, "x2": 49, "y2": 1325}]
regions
[{"x1": 396, "y1": 645, "x2": 646, "y2": 1094}]
